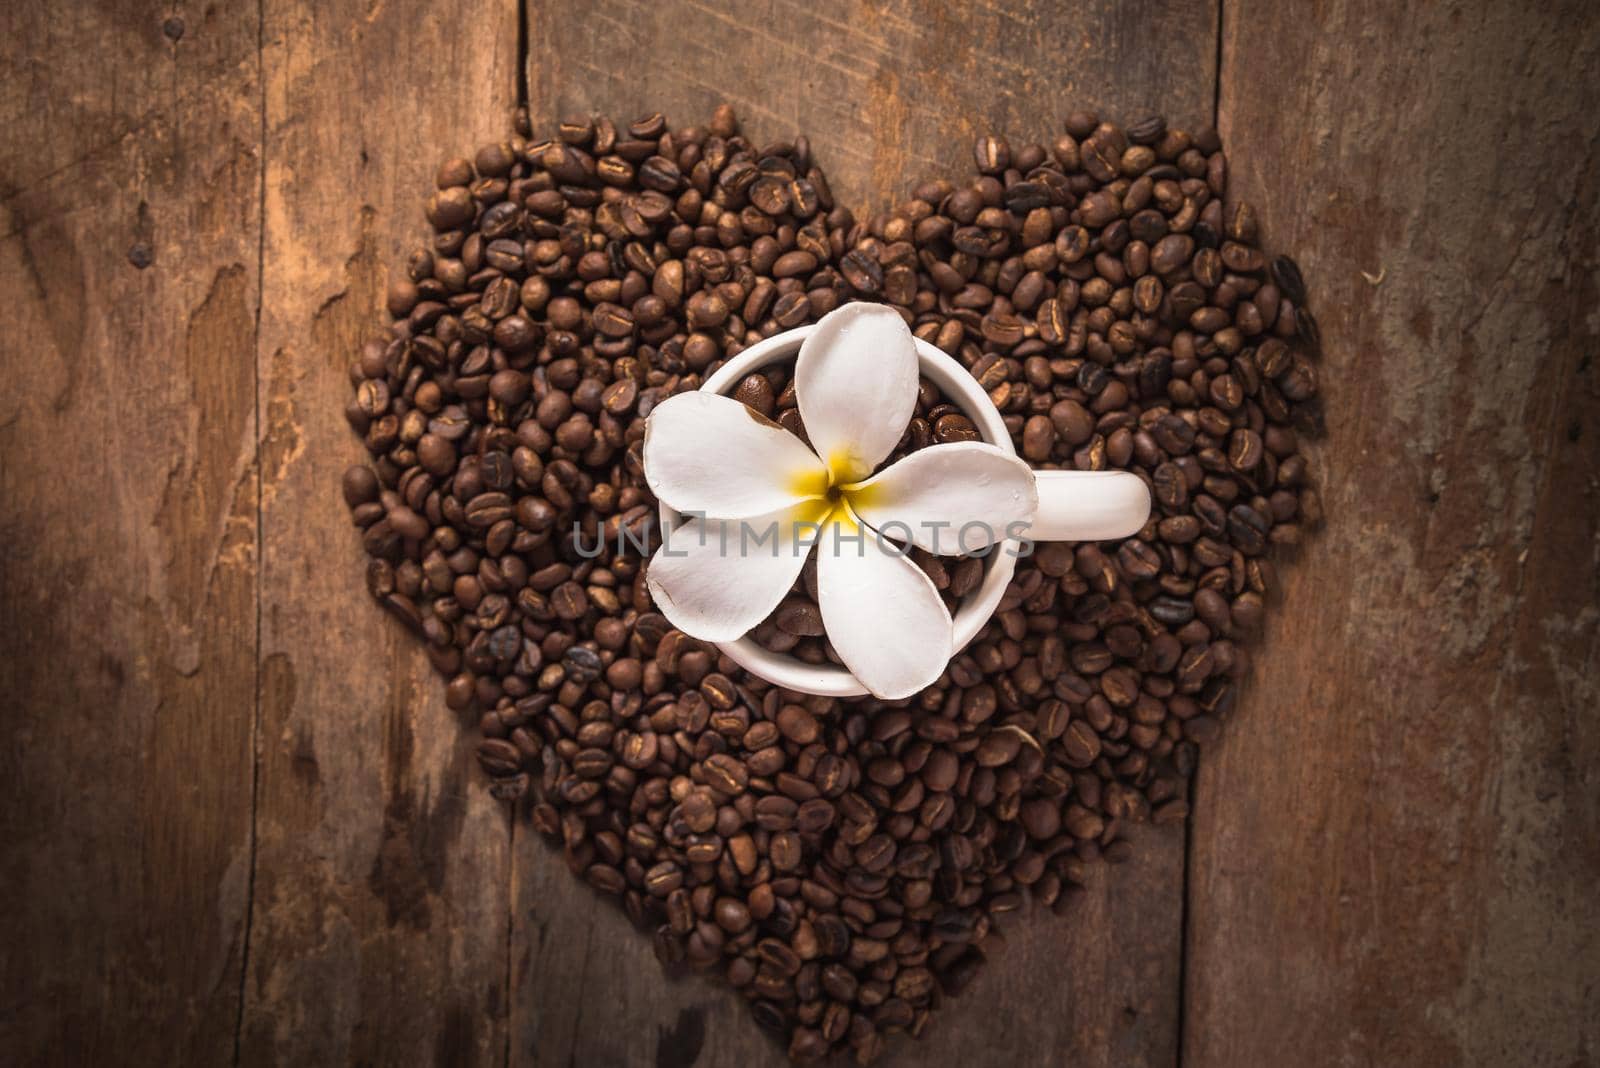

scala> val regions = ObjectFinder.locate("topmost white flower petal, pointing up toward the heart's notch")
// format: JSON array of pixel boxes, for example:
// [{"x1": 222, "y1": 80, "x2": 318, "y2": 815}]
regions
[{"x1": 795, "y1": 304, "x2": 917, "y2": 483}]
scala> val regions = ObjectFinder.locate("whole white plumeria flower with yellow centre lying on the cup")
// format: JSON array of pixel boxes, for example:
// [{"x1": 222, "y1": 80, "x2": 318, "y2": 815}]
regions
[{"x1": 645, "y1": 304, "x2": 1038, "y2": 699}]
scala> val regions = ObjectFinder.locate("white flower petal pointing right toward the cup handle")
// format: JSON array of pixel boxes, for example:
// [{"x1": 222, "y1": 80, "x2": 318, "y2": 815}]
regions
[{"x1": 845, "y1": 441, "x2": 1038, "y2": 556}]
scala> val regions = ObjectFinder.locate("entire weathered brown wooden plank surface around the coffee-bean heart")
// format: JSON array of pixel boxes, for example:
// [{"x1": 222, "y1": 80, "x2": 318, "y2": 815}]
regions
[{"x1": 0, "y1": 0, "x2": 1600, "y2": 1068}]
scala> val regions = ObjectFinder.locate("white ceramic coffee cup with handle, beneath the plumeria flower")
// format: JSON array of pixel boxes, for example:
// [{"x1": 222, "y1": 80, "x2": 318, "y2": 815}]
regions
[{"x1": 661, "y1": 326, "x2": 1150, "y2": 697}]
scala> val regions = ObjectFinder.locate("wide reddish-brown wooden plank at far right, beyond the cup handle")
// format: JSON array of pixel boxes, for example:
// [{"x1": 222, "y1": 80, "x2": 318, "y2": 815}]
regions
[{"x1": 1184, "y1": 2, "x2": 1600, "y2": 1068}]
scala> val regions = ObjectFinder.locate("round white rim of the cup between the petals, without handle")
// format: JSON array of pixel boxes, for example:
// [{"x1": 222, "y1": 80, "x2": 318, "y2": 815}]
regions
[{"x1": 659, "y1": 323, "x2": 1021, "y2": 697}]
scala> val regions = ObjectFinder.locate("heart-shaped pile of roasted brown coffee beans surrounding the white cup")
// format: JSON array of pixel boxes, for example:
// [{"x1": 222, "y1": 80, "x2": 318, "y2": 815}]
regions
[{"x1": 344, "y1": 107, "x2": 1318, "y2": 1063}]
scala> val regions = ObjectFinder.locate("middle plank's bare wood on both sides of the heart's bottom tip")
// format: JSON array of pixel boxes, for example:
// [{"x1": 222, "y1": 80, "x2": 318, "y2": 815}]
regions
[{"x1": 510, "y1": 827, "x2": 1184, "y2": 1068}]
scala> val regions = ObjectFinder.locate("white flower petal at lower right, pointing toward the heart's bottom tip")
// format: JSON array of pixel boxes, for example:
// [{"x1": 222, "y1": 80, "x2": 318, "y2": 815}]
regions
[{"x1": 816, "y1": 508, "x2": 954, "y2": 700}]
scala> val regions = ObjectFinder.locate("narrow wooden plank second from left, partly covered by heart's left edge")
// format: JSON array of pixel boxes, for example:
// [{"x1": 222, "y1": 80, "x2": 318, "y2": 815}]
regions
[{"x1": 242, "y1": 0, "x2": 517, "y2": 1065}]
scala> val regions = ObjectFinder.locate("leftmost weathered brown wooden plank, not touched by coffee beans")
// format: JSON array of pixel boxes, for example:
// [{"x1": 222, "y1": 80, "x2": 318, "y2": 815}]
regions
[{"x1": 0, "y1": 3, "x2": 261, "y2": 1065}]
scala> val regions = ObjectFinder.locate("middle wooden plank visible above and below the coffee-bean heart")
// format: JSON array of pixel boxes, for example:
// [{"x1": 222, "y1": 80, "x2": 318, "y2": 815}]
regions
[{"x1": 510, "y1": 0, "x2": 1216, "y2": 1066}]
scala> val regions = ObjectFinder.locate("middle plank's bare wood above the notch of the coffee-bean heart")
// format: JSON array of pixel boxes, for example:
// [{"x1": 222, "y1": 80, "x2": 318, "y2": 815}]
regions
[{"x1": 528, "y1": 0, "x2": 1218, "y2": 208}]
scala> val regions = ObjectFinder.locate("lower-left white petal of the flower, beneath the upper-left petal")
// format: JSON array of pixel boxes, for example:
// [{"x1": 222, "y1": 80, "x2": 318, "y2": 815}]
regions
[{"x1": 645, "y1": 500, "x2": 827, "y2": 641}]
